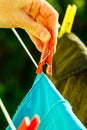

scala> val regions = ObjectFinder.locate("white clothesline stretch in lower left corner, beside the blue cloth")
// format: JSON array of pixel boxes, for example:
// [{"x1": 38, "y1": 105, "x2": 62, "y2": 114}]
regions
[{"x1": 0, "y1": 99, "x2": 17, "y2": 130}]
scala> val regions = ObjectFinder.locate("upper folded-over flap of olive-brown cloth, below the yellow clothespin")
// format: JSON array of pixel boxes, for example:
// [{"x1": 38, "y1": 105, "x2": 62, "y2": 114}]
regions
[{"x1": 53, "y1": 33, "x2": 87, "y2": 81}]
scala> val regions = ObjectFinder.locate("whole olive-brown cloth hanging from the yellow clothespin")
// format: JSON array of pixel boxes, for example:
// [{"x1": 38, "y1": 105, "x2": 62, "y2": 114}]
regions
[{"x1": 51, "y1": 33, "x2": 87, "y2": 127}]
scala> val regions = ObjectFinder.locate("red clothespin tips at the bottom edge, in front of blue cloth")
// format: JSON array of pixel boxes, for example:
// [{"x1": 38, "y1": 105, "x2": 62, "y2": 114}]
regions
[{"x1": 18, "y1": 115, "x2": 40, "y2": 130}]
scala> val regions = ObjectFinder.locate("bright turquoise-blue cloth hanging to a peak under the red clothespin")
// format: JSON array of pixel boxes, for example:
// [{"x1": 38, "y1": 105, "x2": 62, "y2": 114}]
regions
[{"x1": 6, "y1": 73, "x2": 86, "y2": 130}]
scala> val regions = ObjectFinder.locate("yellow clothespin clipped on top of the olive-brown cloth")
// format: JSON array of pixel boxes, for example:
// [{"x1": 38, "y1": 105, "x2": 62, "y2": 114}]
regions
[{"x1": 58, "y1": 5, "x2": 77, "y2": 38}]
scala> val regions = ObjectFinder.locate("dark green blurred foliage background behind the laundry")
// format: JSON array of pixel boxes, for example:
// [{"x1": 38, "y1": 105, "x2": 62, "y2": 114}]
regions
[{"x1": 0, "y1": 0, "x2": 87, "y2": 130}]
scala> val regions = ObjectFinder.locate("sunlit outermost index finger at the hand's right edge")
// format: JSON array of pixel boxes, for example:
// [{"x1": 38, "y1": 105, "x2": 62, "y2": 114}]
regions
[{"x1": 40, "y1": 1, "x2": 58, "y2": 52}]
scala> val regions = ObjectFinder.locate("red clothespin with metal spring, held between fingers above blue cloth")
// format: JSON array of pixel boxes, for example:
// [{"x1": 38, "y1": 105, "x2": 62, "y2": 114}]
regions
[{"x1": 36, "y1": 40, "x2": 54, "y2": 75}]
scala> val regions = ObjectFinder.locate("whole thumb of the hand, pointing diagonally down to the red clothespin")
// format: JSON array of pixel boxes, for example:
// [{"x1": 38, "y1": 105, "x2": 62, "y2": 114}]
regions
[{"x1": 17, "y1": 12, "x2": 51, "y2": 42}]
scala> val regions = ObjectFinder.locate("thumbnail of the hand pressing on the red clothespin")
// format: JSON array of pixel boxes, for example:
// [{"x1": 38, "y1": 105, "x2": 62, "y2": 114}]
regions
[{"x1": 40, "y1": 30, "x2": 51, "y2": 42}]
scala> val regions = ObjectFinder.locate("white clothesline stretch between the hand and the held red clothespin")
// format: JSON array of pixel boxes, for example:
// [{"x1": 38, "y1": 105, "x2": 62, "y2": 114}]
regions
[{"x1": 12, "y1": 28, "x2": 38, "y2": 68}]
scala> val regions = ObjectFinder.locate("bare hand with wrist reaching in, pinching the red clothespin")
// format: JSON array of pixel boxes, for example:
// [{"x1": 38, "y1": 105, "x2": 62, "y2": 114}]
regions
[{"x1": 0, "y1": 0, "x2": 58, "y2": 52}]
